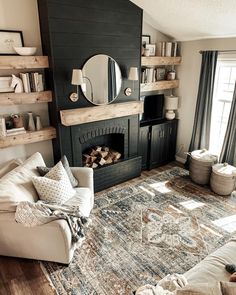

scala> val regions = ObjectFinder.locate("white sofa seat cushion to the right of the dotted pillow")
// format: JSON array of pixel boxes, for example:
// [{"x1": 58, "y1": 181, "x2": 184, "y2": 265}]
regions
[{"x1": 65, "y1": 187, "x2": 92, "y2": 217}]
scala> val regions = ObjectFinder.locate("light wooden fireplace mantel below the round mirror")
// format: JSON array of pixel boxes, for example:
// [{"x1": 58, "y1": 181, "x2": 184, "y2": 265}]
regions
[{"x1": 60, "y1": 101, "x2": 143, "y2": 126}]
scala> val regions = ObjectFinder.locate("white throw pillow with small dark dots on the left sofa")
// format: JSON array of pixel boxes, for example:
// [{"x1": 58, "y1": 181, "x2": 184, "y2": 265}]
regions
[{"x1": 32, "y1": 162, "x2": 76, "y2": 204}]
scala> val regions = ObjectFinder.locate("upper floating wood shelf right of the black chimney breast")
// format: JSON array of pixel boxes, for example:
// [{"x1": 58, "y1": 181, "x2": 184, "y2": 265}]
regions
[{"x1": 141, "y1": 56, "x2": 181, "y2": 67}]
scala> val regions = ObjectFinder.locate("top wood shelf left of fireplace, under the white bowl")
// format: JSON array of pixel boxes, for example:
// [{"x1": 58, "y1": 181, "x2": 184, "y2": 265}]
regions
[{"x1": 0, "y1": 55, "x2": 49, "y2": 70}]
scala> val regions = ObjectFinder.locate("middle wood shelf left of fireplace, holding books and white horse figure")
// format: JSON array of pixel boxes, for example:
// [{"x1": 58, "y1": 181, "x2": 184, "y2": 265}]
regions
[{"x1": 0, "y1": 91, "x2": 52, "y2": 105}]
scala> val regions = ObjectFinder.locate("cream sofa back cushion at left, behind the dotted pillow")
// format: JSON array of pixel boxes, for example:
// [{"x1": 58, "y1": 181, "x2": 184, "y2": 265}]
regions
[{"x1": 0, "y1": 153, "x2": 44, "y2": 212}]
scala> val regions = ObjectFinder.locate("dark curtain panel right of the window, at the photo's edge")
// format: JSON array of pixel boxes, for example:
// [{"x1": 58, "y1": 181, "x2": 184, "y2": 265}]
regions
[{"x1": 220, "y1": 83, "x2": 236, "y2": 166}]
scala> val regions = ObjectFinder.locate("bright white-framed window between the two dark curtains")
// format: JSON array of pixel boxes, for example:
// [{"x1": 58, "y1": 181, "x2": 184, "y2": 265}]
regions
[{"x1": 209, "y1": 57, "x2": 236, "y2": 156}]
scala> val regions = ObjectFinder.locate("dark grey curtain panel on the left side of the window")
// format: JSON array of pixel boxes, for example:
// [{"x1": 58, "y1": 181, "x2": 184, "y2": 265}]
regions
[{"x1": 186, "y1": 51, "x2": 218, "y2": 166}]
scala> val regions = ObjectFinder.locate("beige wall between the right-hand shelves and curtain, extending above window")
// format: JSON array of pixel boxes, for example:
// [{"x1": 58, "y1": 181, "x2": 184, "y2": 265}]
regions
[{"x1": 177, "y1": 38, "x2": 236, "y2": 159}]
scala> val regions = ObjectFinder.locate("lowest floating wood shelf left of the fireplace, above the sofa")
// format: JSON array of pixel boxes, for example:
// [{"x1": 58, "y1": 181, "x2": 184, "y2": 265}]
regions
[{"x1": 0, "y1": 127, "x2": 56, "y2": 149}]
